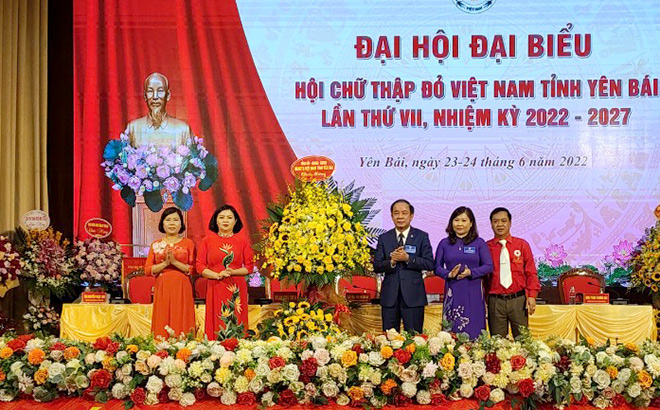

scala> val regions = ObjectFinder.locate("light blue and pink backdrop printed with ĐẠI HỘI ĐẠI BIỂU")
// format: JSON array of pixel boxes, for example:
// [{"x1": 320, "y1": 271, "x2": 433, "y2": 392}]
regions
[{"x1": 238, "y1": 0, "x2": 660, "y2": 263}]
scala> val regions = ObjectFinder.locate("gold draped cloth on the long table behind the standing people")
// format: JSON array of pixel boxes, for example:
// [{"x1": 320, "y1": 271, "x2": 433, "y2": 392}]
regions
[{"x1": 60, "y1": 304, "x2": 657, "y2": 343}]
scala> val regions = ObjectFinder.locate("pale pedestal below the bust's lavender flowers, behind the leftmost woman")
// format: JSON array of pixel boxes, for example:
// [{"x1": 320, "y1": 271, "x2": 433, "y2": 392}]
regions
[{"x1": 133, "y1": 196, "x2": 188, "y2": 258}]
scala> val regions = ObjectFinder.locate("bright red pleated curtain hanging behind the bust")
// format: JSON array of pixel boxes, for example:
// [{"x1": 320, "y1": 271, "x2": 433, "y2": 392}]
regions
[{"x1": 74, "y1": 0, "x2": 295, "y2": 247}]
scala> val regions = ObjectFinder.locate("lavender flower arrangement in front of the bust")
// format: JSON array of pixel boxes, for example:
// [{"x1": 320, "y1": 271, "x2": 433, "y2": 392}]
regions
[{"x1": 101, "y1": 132, "x2": 218, "y2": 212}]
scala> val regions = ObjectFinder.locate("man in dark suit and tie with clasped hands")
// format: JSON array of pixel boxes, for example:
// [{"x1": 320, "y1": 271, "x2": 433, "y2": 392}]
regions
[{"x1": 374, "y1": 199, "x2": 435, "y2": 333}]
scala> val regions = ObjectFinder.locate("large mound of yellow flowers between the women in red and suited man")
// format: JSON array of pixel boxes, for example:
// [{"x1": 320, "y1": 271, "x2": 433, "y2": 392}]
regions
[{"x1": 258, "y1": 180, "x2": 378, "y2": 288}]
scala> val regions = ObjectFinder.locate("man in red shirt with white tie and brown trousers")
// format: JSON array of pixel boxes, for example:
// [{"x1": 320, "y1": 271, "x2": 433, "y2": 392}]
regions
[{"x1": 488, "y1": 208, "x2": 541, "y2": 337}]
